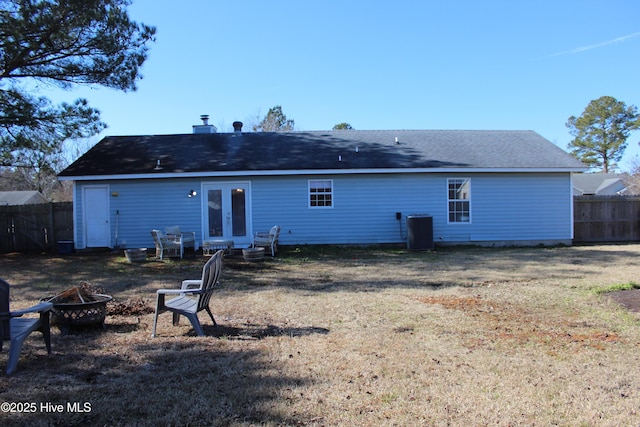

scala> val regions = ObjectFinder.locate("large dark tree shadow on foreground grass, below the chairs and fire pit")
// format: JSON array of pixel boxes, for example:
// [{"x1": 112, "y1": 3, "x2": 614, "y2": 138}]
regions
[{"x1": 0, "y1": 325, "x2": 328, "y2": 426}]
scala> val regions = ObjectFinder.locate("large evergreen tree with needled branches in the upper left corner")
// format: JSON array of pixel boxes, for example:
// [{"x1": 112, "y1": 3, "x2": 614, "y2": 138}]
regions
[{"x1": 0, "y1": 0, "x2": 156, "y2": 176}]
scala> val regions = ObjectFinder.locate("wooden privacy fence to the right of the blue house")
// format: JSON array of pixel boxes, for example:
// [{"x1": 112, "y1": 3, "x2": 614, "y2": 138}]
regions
[{"x1": 573, "y1": 196, "x2": 640, "y2": 242}]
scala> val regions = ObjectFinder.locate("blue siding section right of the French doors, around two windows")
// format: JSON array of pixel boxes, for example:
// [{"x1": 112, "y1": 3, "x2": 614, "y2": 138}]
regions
[{"x1": 253, "y1": 174, "x2": 573, "y2": 244}]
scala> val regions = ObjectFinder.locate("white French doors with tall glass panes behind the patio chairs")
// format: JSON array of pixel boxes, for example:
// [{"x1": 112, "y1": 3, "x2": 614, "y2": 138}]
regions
[{"x1": 202, "y1": 182, "x2": 251, "y2": 247}]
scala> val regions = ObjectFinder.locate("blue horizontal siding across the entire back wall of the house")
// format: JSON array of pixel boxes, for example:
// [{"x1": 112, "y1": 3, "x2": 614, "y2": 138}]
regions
[{"x1": 76, "y1": 173, "x2": 573, "y2": 247}]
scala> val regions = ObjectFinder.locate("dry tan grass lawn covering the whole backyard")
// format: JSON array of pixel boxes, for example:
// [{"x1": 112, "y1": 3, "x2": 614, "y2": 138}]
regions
[{"x1": 0, "y1": 245, "x2": 640, "y2": 426}]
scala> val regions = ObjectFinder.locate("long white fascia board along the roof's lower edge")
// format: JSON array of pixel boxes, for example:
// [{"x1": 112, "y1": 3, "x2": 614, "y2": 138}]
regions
[{"x1": 58, "y1": 168, "x2": 587, "y2": 181}]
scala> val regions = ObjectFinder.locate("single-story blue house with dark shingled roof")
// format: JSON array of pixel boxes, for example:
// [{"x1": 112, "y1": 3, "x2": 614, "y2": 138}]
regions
[{"x1": 59, "y1": 121, "x2": 586, "y2": 249}]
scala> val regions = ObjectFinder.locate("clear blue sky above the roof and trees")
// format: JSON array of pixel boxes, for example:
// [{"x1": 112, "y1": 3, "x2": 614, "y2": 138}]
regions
[{"x1": 52, "y1": 0, "x2": 640, "y2": 170}]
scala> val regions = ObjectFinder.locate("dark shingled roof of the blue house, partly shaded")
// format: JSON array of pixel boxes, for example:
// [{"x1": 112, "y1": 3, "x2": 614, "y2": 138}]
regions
[{"x1": 60, "y1": 130, "x2": 584, "y2": 177}]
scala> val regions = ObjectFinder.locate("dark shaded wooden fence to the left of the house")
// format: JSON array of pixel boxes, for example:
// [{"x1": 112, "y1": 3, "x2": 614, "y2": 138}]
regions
[{"x1": 0, "y1": 202, "x2": 73, "y2": 253}]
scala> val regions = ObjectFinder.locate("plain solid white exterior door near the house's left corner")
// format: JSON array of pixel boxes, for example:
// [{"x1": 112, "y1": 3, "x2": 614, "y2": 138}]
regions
[{"x1": 82, "y1": 186, "x2": 111, "y2": 248}]
